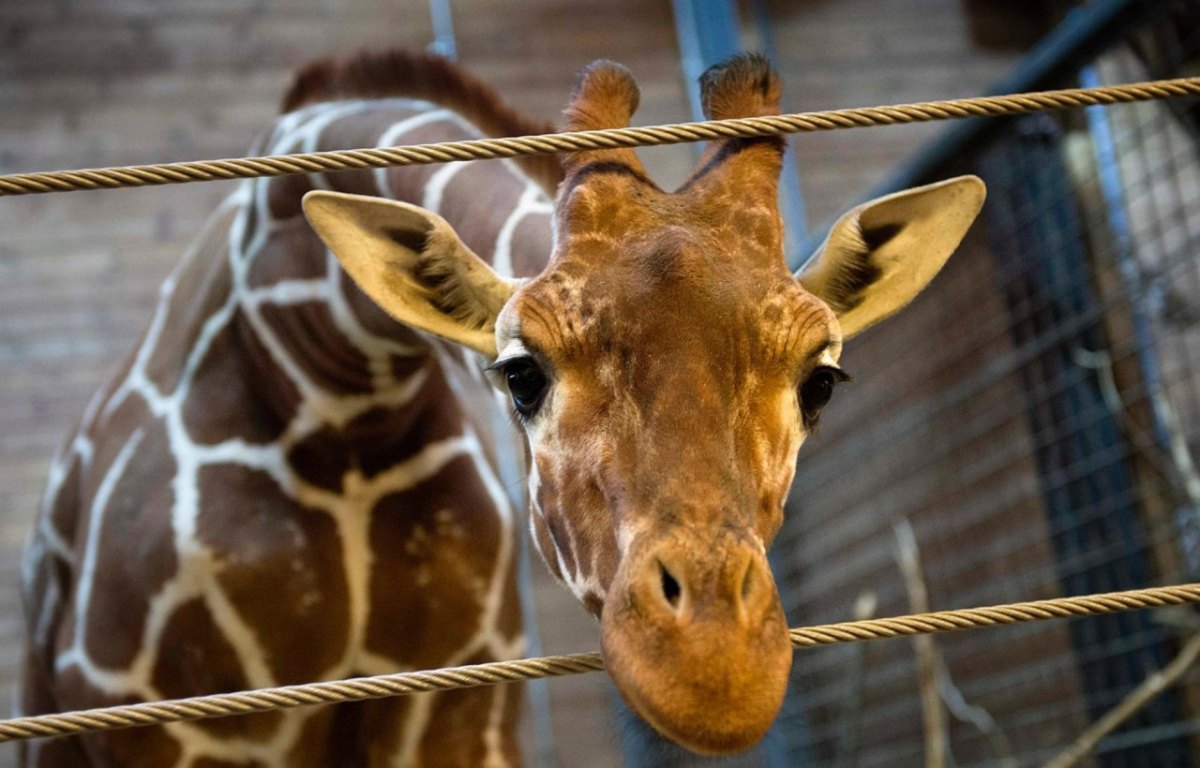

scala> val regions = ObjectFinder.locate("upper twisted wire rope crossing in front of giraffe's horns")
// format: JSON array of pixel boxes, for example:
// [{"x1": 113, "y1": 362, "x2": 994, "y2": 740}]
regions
[{"x1": 0, "y1": 77, "x2": 1200, "y2": 197}]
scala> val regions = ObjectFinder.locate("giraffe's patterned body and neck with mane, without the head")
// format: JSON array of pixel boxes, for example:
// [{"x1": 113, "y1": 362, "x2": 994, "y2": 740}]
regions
[{"x1": 19, "y1": 54, "x2": 562, "y2": 768}]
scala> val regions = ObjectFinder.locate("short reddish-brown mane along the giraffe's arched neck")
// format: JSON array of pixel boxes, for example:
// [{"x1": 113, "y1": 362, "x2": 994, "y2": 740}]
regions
[{"x1": 282, "y1": 50, "x2": 563, "y2": 196}]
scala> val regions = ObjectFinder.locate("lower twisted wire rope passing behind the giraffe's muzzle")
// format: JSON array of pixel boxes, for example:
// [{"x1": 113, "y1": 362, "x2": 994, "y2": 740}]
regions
[{"x1": 0, "y1": 583, "x2": 1200, "y2": 743}]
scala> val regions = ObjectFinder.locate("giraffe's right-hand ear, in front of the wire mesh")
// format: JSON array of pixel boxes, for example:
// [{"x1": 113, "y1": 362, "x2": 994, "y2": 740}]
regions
[{"x1": 796, "y1": 176, "x2": 986, "y2": 338}]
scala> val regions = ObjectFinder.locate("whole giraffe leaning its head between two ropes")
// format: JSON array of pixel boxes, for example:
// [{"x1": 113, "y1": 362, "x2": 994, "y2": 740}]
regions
[{"x1": 16, "y1": 55, "x2": 983, "y2": 767}]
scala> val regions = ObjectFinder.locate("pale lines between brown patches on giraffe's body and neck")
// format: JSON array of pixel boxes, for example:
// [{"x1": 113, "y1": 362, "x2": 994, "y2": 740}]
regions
[{"x1": 23, "y1": 100, "x2": 551, "y2": 768}]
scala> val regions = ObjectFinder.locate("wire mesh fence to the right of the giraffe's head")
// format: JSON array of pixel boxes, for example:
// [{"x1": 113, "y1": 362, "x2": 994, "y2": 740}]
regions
[{"x1": 775, "y1": 1, "x2": 1200, "y2": 768}]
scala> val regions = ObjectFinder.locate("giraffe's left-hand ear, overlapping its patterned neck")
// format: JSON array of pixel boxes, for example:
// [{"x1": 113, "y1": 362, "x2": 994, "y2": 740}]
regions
[{"x1": 304, "y1": 191, "x2": 515, "y2": 358}]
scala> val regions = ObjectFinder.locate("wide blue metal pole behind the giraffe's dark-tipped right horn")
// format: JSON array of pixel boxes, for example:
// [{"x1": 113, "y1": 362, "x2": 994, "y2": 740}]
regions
[{"x1": 672, "y1": 0, "x2": 808, "y2": 269}]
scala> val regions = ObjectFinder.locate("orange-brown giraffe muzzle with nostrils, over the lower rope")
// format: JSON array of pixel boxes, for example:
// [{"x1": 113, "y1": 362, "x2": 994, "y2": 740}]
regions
[{"x1": 601, "y1": 534, "x2": 792, "y2": 754}]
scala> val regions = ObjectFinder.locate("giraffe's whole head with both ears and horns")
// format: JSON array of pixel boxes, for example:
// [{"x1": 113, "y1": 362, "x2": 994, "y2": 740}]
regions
[{"x1": 305, "y1": 56, "x2": 984, "y2": 752}]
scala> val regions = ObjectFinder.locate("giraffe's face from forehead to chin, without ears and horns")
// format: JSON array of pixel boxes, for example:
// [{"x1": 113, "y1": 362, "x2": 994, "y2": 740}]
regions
[{"x1": 492, "y1": 218, "x2": 842, "y2": 752}]
